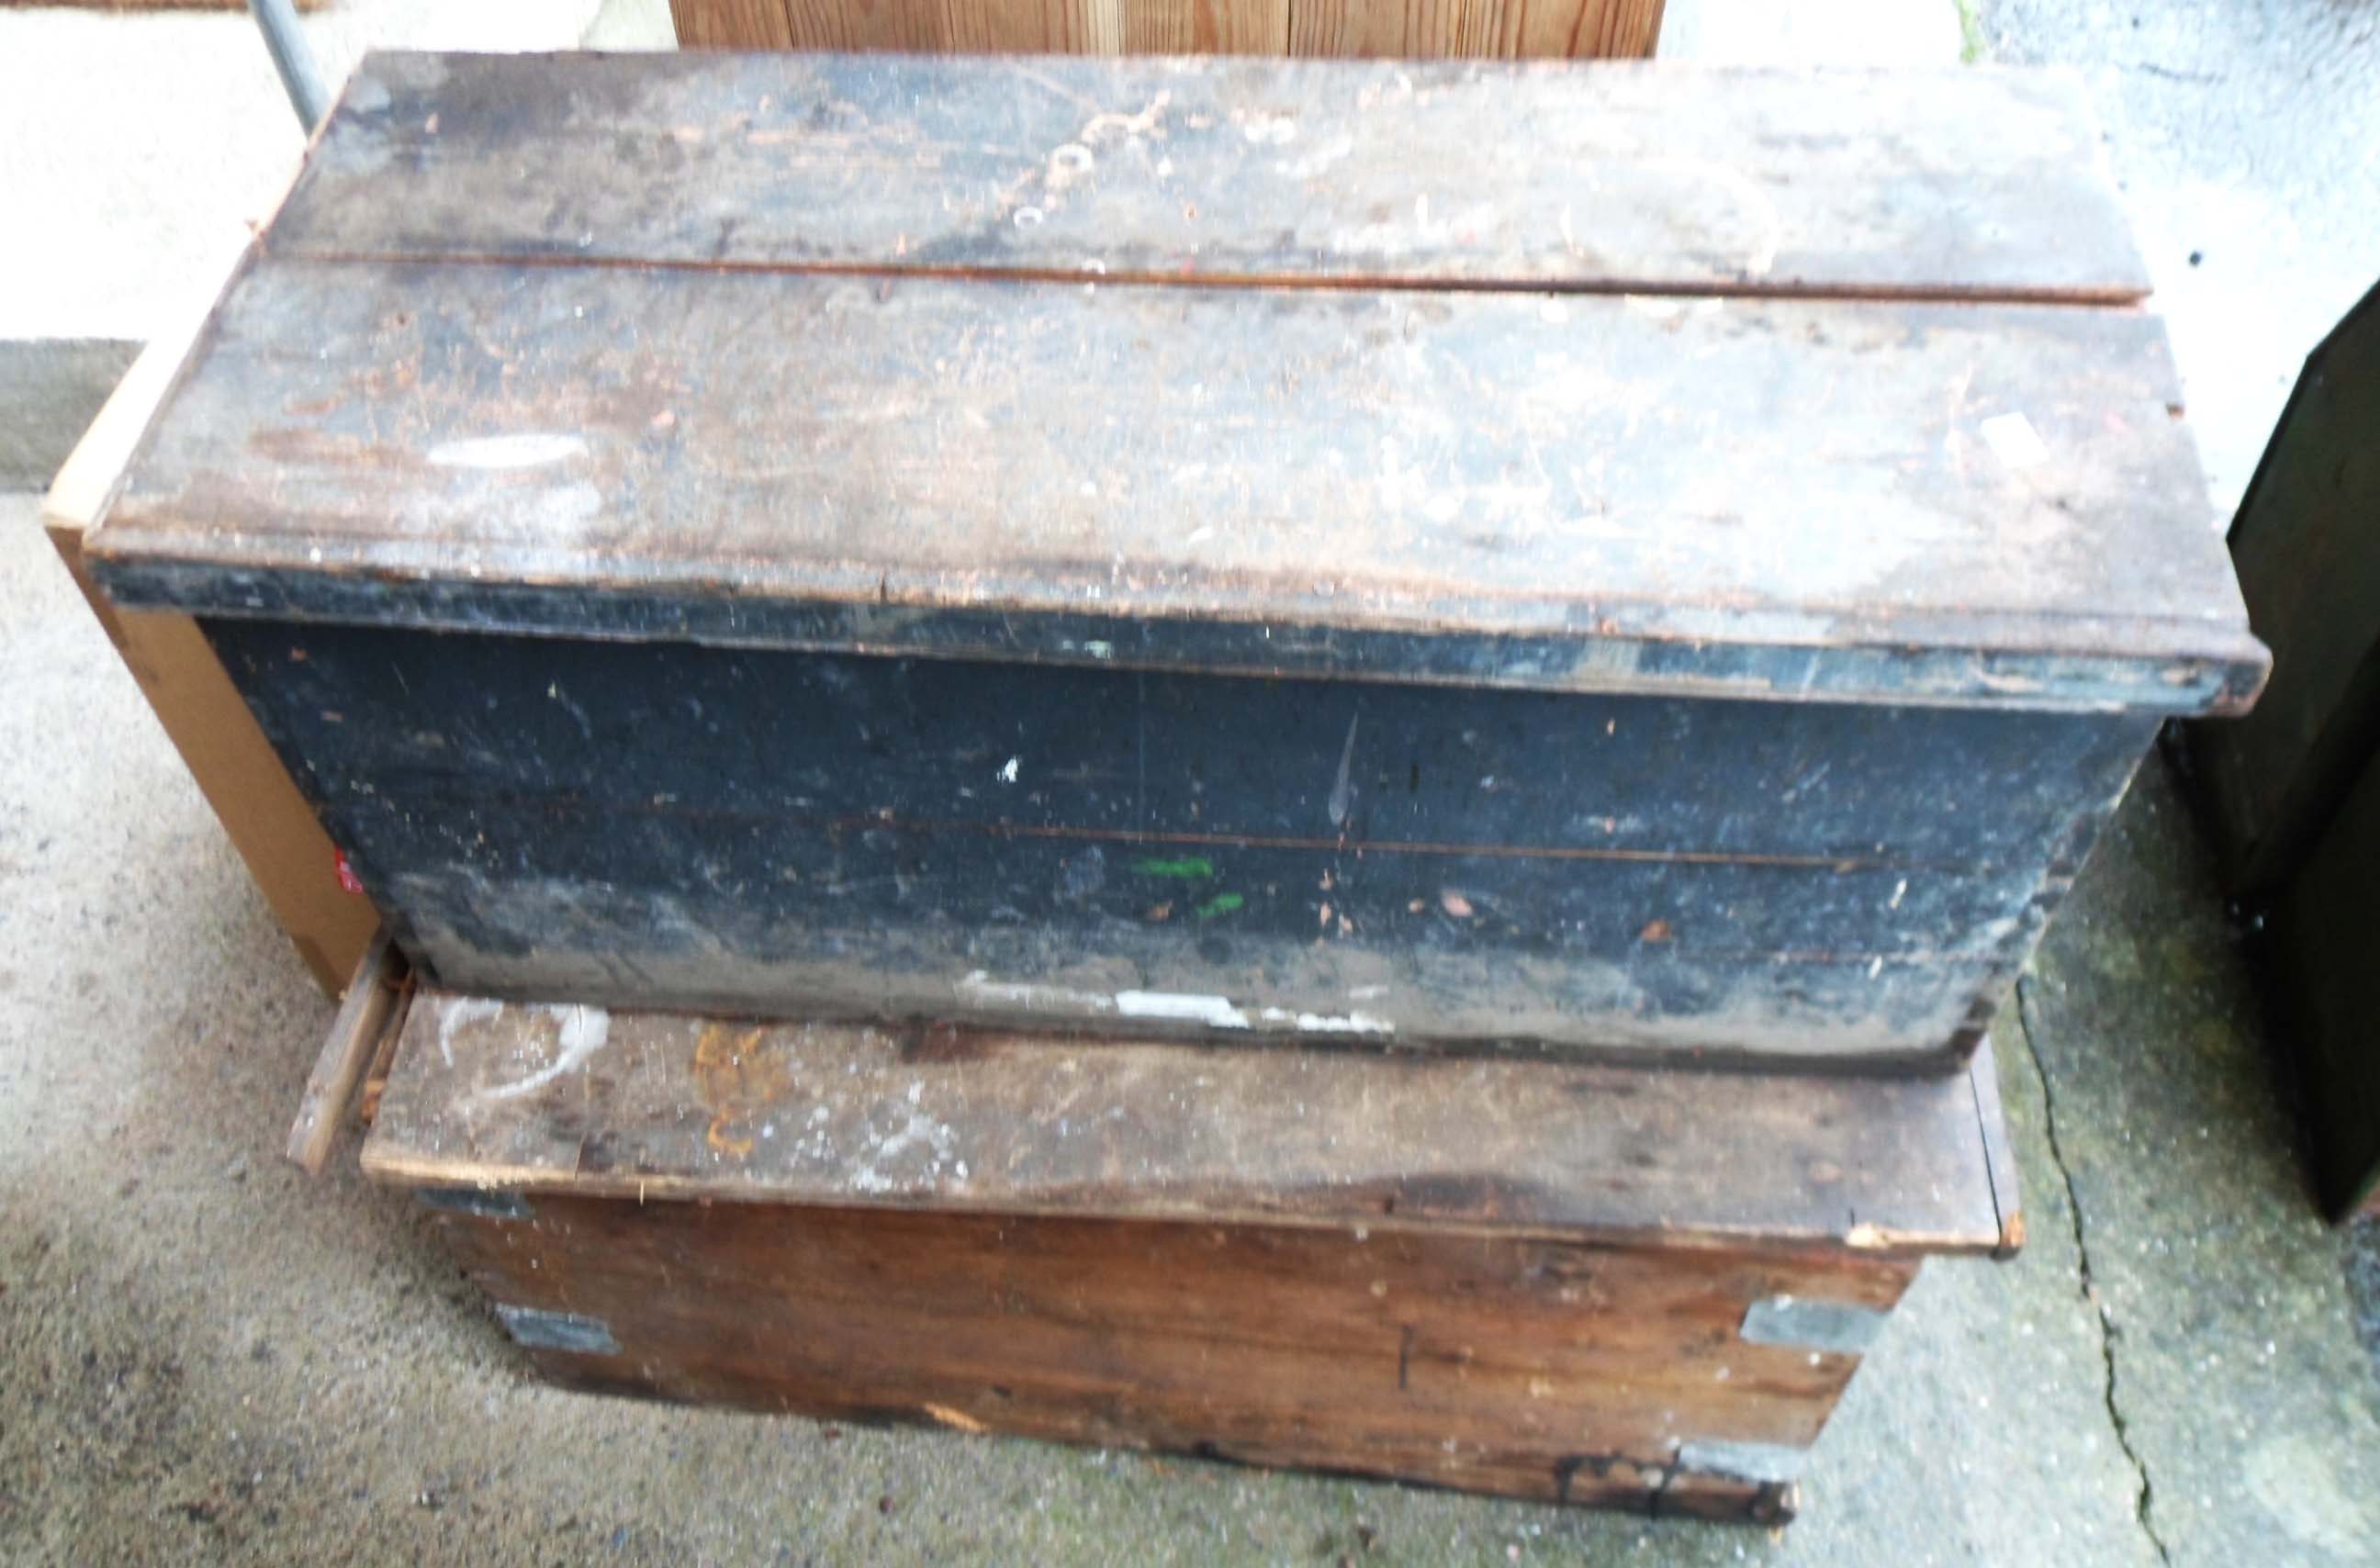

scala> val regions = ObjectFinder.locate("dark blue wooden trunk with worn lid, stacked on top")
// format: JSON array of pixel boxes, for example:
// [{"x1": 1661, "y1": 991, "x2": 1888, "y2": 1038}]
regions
[{"x1": 90, "y1": 55, "x2": 2263, "y2": 1069}]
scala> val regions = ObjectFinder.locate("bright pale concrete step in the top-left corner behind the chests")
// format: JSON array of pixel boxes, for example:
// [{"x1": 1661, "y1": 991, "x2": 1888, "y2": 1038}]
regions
[{"x1": 0, "y1": 0, "x2": 674, "y2": 487}]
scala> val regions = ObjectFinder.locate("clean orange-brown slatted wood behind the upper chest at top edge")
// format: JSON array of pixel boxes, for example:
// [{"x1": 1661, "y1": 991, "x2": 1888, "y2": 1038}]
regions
[{"x1": 668, "y1": 0, "x2": 1661, "y2": 60}]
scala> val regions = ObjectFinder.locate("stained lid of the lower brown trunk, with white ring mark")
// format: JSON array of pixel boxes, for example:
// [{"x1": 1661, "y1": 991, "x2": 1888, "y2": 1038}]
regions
[{"x1": 365, "y1": 992, "x2": 2004, "y2": 1256}]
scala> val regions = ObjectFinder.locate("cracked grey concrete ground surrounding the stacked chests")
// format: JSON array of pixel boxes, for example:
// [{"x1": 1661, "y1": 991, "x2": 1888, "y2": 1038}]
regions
[{"x1": 0, "y1": 0, "x2": 2380, "y2": 1565}]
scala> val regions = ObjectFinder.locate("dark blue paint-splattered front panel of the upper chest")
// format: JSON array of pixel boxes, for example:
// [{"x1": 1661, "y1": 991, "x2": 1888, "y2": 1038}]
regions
[{"x1": 212, "y1": 621, "x2": 2151, "y2": 1066}]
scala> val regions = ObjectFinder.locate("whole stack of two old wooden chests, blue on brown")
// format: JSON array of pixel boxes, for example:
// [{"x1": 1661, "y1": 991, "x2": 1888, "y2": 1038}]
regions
[{"x1": 88, "y1": 55, "x2": 2263, "y2": 1516}]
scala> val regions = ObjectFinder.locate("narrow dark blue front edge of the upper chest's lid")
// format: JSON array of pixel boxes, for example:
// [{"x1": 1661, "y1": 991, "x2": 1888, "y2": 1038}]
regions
[{"x1": 90, "y1": 559, "x2": 2271, "y2": 716}]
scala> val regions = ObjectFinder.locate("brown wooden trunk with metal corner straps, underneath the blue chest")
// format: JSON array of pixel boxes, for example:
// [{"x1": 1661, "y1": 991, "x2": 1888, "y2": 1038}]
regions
[{"x1": 365, "y1": 994, "x2": 2018, "y2": 1523}]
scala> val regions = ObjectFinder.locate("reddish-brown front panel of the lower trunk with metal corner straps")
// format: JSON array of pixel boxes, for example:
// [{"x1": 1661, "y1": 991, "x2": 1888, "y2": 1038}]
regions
[{"x1": 409, "y1": 1189, "x2": 1916, "y2": 1523}]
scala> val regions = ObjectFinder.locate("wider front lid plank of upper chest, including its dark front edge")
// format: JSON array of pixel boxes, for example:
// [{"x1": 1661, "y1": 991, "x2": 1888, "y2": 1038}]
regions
[{"x1": 90, "y1": 260, "x2": 2266, "y2": 711}]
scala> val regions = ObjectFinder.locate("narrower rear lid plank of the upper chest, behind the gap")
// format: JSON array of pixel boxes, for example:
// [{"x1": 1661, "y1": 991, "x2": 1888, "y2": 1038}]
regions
[{"x1": 266, "y1": 51, "x2": 2147, "y2": 302}]
